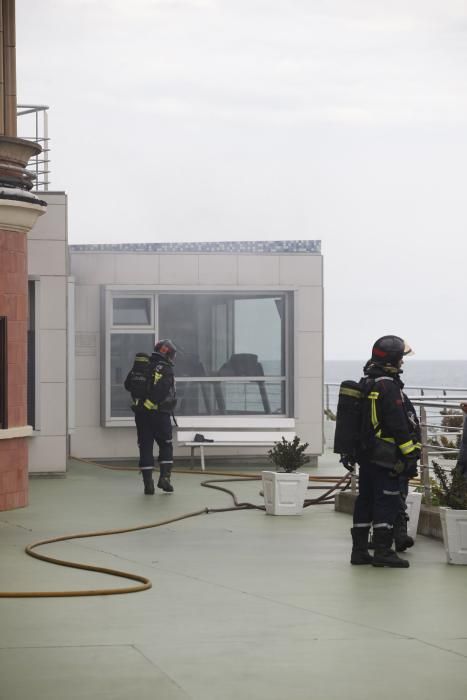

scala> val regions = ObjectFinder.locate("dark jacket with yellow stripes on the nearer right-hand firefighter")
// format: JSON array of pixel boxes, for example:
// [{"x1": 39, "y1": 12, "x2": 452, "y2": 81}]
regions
[{"x1": 362, "y1": 364, "x2": 421, "y2": 459}]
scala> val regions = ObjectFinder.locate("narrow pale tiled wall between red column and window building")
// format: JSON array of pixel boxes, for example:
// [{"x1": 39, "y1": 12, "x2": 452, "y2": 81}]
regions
[{"x1": 28, "y1": 192, "x2": 68, "y2": 473}]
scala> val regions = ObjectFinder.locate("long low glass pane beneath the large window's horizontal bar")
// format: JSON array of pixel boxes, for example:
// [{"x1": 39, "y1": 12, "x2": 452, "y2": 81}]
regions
[{"x1": 175, "y1": 379, "x2": 285, "y2": 416}]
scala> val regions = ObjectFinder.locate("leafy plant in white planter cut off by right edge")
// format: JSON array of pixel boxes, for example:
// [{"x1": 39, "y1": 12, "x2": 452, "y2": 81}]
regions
[{"x1": 432, "y1": 461, "x2": 467, "y2": 565}]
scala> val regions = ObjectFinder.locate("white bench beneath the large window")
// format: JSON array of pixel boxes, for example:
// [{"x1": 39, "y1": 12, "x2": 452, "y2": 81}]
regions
[{"x1": 177, "y1": 430, "x2": 295, "y2": 472}]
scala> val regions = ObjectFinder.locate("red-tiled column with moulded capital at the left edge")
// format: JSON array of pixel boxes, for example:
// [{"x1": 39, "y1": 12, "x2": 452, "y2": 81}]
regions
[{"x1": 0, "y1": 135, "x2": 46, "y2": 511}]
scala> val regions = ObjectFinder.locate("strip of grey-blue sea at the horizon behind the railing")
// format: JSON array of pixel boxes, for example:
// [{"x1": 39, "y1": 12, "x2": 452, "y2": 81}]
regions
[{"x1": 324, "y1": 357, "x2": 467, "y2": 394}]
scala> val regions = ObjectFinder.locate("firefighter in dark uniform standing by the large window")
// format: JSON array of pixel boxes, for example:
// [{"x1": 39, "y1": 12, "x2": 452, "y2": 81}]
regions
[{"x1": 125, "y1": 340, "x2": 176, "y2": 495}]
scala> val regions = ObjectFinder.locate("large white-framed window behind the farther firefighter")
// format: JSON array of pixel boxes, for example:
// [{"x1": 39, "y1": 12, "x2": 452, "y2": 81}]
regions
[{"x1": 106, "y1": 292, "x2": 291, "y2": 420}]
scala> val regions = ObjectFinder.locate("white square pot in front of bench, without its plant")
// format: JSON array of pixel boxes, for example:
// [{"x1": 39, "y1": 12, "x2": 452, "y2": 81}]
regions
[{"x1": 261, "y1": 471, "x2": 308, "y2": 515}]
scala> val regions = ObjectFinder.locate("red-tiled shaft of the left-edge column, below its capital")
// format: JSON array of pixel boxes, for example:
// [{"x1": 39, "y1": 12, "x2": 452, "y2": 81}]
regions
[{"x1": 0, "y1": 229, "x2": 28, "y2": 511}]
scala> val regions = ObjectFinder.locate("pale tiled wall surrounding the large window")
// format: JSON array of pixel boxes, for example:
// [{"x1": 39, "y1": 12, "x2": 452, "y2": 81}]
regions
[{"x1": 70, "y1": 249, "x2": 323, "y2": 458}]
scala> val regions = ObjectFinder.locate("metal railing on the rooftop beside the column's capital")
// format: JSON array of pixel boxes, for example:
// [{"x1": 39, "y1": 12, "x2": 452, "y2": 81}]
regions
[{"x1": 16, "y1": 105, "x2": 50, "y2": 192}]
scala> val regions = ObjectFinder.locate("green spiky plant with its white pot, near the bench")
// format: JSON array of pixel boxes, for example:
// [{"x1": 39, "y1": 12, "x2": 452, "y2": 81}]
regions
[{"x1": 261, "y1": 436, "x2": 310, "y2": 515}]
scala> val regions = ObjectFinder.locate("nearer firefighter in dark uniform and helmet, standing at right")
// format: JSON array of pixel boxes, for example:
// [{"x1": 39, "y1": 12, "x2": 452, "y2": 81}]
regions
[{"x1": 350, "y1": 335, "x2": 421, "y2": 568}]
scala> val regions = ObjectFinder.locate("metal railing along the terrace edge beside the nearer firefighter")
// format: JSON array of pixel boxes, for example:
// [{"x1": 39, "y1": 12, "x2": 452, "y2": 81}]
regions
[{"x1": 324, "y1": 382, "x2": 467, "y2": 505}]
